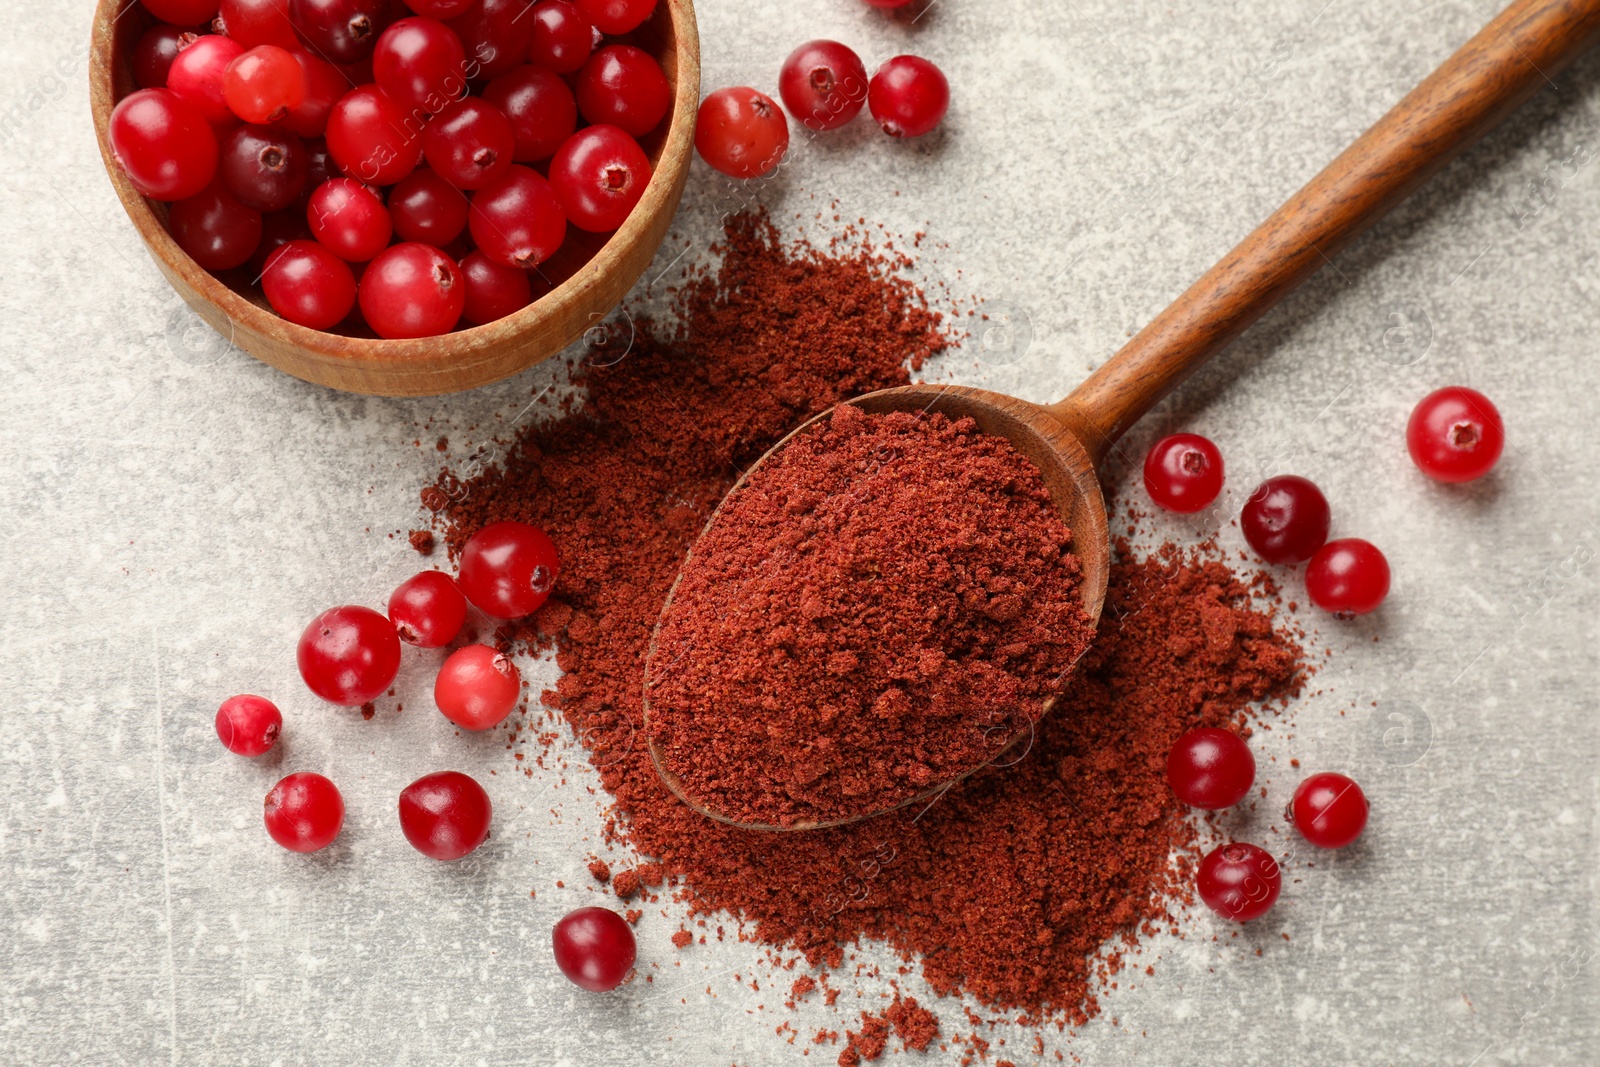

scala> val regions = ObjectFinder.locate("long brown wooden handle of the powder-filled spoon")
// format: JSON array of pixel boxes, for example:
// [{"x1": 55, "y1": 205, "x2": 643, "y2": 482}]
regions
[{"x1": 1050, "y1": 0, "x2": 1600, "y2": 464}]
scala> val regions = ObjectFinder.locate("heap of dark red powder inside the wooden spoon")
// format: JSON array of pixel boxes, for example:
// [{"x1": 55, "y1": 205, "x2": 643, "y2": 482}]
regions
[{"x1": 646, "y1": 405, "x2": 1093, "y2": 827}]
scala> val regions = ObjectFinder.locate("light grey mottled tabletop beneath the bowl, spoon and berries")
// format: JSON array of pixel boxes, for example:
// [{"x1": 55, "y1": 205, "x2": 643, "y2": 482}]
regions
[{"x1": 0, "y1": 0, "x2": 1600, "y2": 1065}]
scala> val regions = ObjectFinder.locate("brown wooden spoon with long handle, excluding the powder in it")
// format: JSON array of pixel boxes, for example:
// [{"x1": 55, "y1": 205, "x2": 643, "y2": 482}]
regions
[{"x1": 645, "y1": 0, "x2": 1600, "y2": 830}]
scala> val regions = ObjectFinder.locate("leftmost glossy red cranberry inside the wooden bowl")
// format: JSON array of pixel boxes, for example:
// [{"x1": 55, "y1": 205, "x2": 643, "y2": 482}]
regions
[{"x1": 110, "y1": 90, "x2": 218, "y2": 200}]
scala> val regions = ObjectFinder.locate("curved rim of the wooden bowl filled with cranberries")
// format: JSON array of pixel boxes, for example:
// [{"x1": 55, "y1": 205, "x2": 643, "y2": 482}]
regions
[{"x1": 88, "y1": 0, "x2": 699, "y2": 384}]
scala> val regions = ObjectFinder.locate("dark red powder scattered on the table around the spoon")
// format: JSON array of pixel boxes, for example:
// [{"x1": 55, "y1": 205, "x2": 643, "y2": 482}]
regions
[{"x1": 424, "y1": 218, "x2": 1299, "y2": 1022}]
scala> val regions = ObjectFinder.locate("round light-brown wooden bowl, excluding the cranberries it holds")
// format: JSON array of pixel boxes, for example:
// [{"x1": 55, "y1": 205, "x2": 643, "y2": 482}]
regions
[{"x1": 90, "y1": 0, "x2": 699, "y2": 397}]
